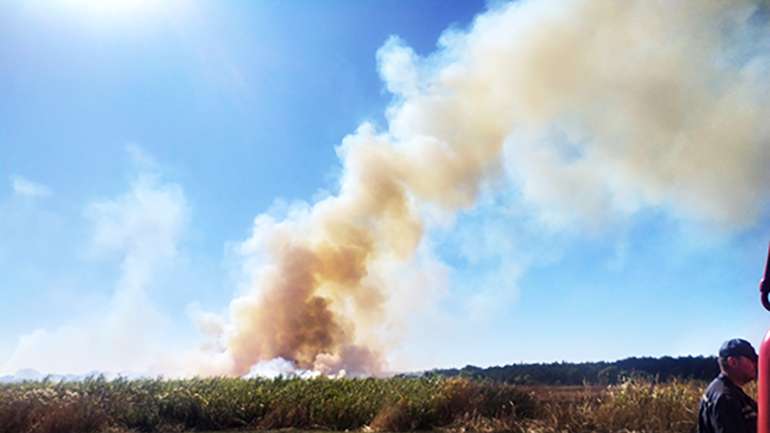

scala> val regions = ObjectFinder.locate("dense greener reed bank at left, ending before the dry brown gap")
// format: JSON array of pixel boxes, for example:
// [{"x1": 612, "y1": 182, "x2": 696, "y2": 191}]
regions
[{"x1": 0, "y1": 378, "x2": 536, "y2": 433}]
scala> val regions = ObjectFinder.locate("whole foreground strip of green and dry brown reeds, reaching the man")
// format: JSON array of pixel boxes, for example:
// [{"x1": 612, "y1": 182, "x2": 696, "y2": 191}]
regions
[{"x1": 0, "y1": 377, "x2": 720, "y2": 433}]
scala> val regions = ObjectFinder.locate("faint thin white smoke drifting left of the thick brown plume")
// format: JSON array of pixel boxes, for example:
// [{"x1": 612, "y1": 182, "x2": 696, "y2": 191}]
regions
[{"x1": 0, "y1": 170, "x2": 187, "y2": 374}]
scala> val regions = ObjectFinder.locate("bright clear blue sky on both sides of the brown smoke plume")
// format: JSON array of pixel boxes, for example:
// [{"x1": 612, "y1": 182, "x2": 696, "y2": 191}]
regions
[{"x1": 0, "y1": 0, "x2": 770, "y2": 373}]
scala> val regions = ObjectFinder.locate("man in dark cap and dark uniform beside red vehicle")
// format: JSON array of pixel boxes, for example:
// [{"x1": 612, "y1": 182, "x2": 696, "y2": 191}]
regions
[{"x1": 698, "y1": 338, "x2": 757, "y2": 433}]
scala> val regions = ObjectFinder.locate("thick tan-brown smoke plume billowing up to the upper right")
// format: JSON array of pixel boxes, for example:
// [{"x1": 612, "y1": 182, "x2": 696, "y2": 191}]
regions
[{"x1": 208, "y1": 0, "x2": 770, "y2": 374}]
